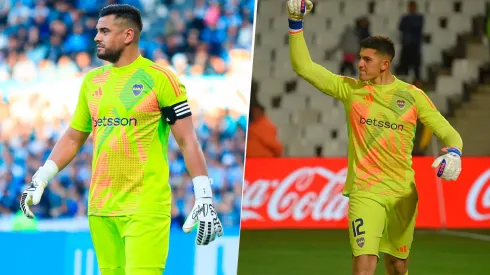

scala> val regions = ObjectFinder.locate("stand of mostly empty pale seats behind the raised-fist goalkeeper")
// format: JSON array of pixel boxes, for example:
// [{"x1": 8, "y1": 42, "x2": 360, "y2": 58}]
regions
[{"x1": 253, "y1": 0, "x2": 490, "y2": 157}]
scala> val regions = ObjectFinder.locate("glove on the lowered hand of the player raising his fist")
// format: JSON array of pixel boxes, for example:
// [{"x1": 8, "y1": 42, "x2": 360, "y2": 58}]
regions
[{"x1": 432, "y1": 147, "x2": 461, "y2": 181}]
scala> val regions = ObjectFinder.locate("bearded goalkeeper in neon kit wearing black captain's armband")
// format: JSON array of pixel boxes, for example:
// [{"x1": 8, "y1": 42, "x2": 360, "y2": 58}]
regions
[{"x1": 20, "y1": 5, "x2": 223, "y2": 275}]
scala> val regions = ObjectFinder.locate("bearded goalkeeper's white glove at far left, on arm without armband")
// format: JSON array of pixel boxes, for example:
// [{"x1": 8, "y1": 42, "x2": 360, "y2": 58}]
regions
[{"x1": 20, "y1": 160, "x2": 58, "y2": 219}]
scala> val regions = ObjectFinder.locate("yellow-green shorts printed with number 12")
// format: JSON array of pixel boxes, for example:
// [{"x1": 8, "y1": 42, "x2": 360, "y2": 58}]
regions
[{"x1": 348, "y1": 194, "x2": 418, "y2": 259}]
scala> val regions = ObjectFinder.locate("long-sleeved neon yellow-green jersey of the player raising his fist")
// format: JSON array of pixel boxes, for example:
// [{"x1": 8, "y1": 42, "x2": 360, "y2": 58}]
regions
[{"x1": 290, "y1": 32, "x2": 463, "y2": 196}]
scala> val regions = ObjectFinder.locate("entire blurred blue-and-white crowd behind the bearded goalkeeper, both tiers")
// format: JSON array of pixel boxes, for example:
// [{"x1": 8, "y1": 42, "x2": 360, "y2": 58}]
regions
[{"x1": 0, "y1": 0, "x2": 254, "y2": 229}]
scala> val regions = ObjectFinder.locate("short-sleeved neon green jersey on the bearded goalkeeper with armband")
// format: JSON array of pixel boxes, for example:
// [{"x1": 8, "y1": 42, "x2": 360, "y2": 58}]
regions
[{"x1": 70, "y1": 56, "x2": 191, "y2": 216}]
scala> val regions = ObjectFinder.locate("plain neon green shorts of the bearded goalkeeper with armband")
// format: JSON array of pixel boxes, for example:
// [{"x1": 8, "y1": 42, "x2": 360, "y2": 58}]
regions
[{"x1": 88, "y1": 214, "x2": 171, "y2": 275}]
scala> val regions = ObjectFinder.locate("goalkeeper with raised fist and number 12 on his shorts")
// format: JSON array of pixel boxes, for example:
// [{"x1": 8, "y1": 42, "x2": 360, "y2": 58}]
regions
[{"x1": 287, "y1": 0, "x2": 463, "y2": 275}]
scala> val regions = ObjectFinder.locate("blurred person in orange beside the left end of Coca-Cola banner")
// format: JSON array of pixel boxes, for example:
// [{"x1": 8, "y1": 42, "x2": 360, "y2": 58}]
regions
[{"x1": 247, "y1": 101, "x2": 283, "y2": 158}]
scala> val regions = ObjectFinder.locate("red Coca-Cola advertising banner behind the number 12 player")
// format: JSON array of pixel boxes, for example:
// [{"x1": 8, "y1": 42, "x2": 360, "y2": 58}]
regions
[{"x1": 241, "y1": 157, "x2": 490, "y2": 229}]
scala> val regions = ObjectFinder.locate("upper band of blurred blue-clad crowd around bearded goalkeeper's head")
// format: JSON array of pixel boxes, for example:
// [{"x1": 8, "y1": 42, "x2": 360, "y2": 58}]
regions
[{"x1": 0, "y1": 0, "x2": 254, "y2": 81}]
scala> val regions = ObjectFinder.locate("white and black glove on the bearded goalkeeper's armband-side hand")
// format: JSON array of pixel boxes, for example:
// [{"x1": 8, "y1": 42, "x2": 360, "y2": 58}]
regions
[{"x1": 182, "y1": 176, "x2": 223, "y2": 245}]
